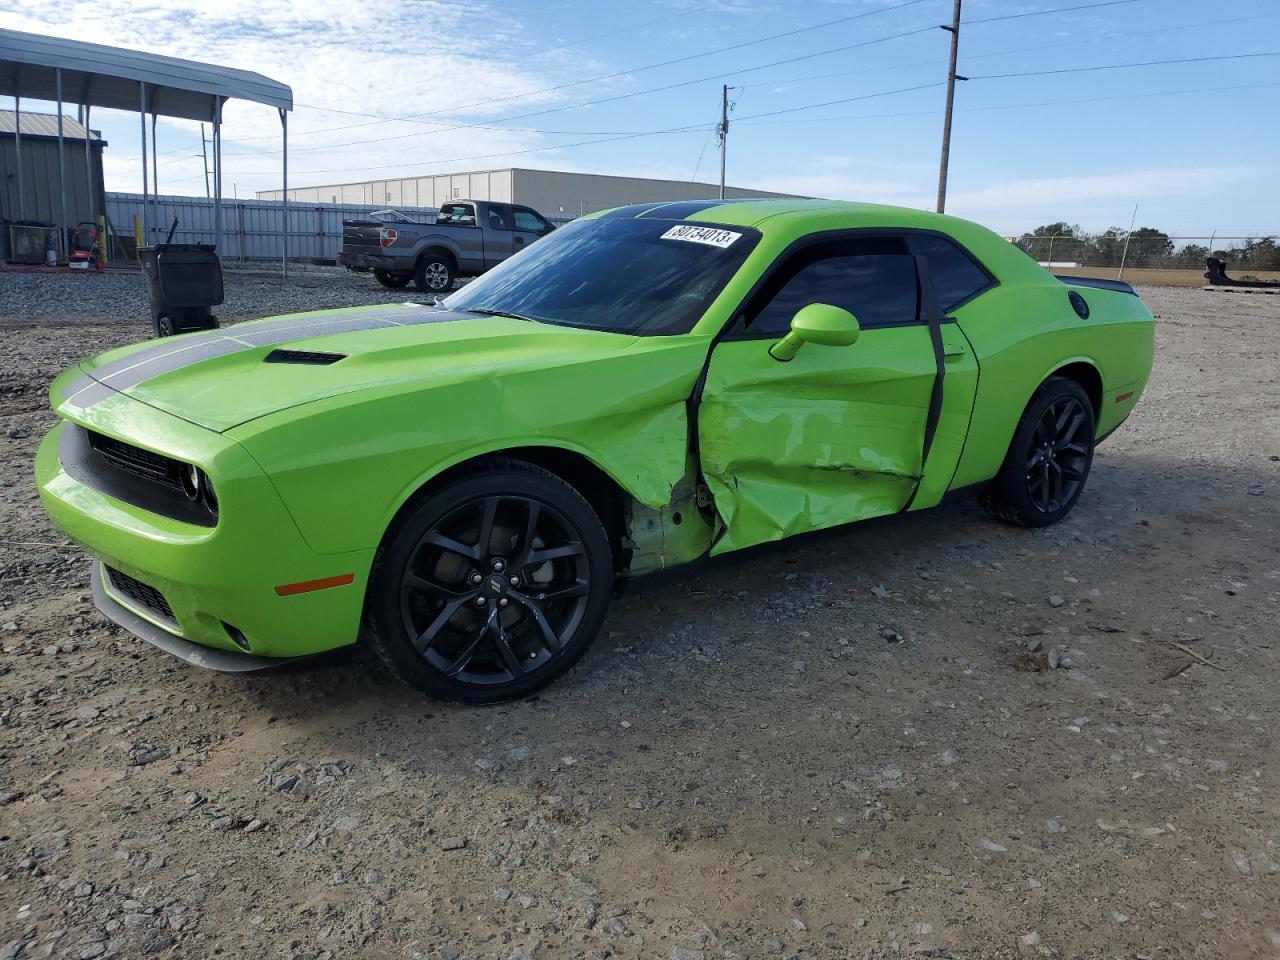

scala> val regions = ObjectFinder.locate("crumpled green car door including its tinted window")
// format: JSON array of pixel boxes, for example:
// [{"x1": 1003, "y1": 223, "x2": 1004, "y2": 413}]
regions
[{"x1": 698, "y1": 232, "x2": 978, "y2": 554}]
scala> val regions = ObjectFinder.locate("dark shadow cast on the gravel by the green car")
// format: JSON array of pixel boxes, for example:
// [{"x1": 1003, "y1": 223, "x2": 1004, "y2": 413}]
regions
[{"x1": 192, "y1": 448, "x2": 1280, "y2": 765}]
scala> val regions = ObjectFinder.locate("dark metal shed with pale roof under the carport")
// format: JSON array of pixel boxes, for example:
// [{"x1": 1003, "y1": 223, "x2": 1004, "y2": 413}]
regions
[{"x1": 0, "y1": 110, "x2": 106, "y2": 259}]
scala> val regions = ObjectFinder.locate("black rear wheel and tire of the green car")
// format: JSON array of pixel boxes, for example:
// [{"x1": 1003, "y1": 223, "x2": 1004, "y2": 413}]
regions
[{"x1": 982, "y1": 376, "x2": 1096, "y2": 527}]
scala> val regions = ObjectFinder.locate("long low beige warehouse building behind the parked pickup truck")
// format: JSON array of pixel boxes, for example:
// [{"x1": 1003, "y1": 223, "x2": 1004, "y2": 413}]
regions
[{"x1": 257, "y1": 168, "x2": 795, "y2": 218}]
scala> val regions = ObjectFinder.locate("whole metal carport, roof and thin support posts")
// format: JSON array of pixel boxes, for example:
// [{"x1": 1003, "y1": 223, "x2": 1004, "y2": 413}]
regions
[{"x1": 0, "y1": 29, "x2": 293, "y2": 271}]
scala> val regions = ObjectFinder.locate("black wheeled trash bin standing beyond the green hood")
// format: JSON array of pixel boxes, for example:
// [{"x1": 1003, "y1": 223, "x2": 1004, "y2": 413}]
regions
[{"x1": 138, "y1": 232, "x2": 223, "y2": 337}]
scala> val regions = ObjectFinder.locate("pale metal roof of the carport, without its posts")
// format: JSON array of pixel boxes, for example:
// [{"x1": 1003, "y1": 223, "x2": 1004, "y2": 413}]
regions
[{"x1": 0, "y1": 29, "x2": 293, "y2": 120}]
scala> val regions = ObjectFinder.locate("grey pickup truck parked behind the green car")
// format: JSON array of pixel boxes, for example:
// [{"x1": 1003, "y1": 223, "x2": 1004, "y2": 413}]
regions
[{"x1": 338, "y1": 200, "x2": 556, "y2": 294}]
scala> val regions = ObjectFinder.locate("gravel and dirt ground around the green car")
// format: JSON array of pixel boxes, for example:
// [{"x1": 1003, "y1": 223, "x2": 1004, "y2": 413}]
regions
[{"x1": 0, "y1": 280, "x2": 1280, "y2": 960}]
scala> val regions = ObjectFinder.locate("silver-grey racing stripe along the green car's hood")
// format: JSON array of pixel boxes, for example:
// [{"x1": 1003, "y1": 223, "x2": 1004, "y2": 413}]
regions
[{"x1": 67, "y1": 307, "x2": 470, "y2": 408}]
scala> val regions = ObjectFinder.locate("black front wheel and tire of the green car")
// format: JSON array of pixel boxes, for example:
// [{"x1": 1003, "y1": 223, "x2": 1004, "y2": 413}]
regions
[{"x1": 365, "y1": 458, "x2": 613, "y2": 704}]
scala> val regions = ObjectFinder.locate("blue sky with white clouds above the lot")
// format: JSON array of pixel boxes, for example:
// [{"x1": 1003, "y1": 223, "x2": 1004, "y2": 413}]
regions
[{"x1": 0, "y1": 0, "x2": 1280, "y2": 236}]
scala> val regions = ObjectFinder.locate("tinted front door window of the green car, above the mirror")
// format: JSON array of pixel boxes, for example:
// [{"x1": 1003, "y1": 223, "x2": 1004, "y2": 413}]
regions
[{"x1": 746, "y1": 237, "x2": 920, "y2": 337}]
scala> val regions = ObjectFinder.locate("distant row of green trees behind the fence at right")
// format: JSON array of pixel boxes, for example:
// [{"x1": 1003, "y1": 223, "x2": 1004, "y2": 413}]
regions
[{"x1": 1014, "y1": 220, "x2": 1280, "y2": 270}]
